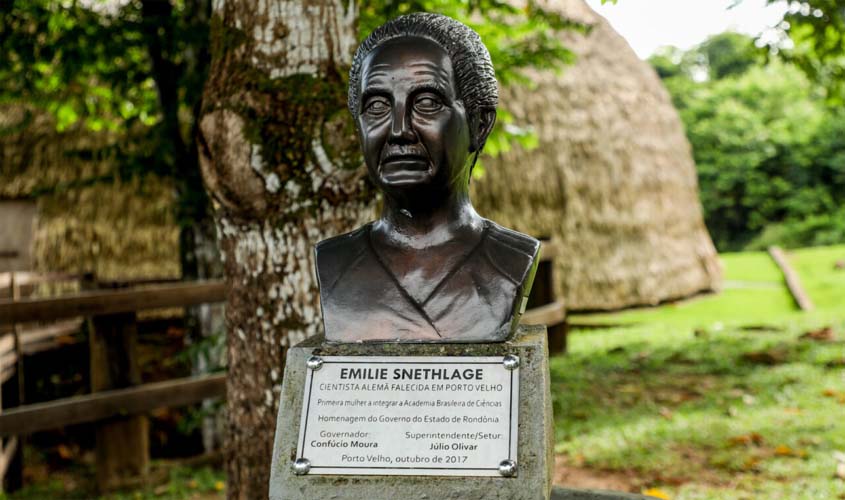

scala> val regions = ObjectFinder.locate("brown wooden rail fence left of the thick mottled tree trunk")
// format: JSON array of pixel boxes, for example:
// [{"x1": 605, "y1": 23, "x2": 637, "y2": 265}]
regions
[{"x1": 0, "y1": 280, "x2": 226, "y2": 489}]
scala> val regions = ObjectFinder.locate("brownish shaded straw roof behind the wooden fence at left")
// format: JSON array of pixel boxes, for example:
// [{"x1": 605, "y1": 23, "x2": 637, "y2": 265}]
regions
[{"x1": 0, "y1": 105, "x2": 180, "y2": 280}]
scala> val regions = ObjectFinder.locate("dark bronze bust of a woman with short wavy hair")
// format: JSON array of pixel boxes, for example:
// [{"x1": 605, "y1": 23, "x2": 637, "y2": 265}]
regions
[{"x1": 315, "y1": 13, "x2": 540, "y2": 342}]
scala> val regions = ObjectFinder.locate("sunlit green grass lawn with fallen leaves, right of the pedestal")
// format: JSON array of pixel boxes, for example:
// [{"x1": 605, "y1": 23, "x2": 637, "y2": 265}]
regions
[{"x1": 551, "y1": 246, "x2": 845, "y2": 500}]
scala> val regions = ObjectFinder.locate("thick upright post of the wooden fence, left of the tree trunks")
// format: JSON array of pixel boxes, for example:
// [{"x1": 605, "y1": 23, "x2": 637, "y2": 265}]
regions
[{"x1": 88, "y1": 280, "x2": 150, "y2": 491}]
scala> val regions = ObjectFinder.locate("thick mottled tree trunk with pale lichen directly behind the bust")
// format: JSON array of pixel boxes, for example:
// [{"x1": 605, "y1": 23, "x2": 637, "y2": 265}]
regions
[{"x1": 198, "y1": 0, "x2": 373, "y2": 499}]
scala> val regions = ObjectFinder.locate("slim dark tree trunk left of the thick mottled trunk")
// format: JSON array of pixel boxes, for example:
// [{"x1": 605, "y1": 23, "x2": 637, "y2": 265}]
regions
[{"x1": 141, "y1": 0, "x2": 224, "y2": 452}]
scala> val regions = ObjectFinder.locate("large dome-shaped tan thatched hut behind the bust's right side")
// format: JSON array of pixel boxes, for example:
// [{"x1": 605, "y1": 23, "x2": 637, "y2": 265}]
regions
[{"x1": 473, "y1": 0, "x2": 721, "y2": 310}]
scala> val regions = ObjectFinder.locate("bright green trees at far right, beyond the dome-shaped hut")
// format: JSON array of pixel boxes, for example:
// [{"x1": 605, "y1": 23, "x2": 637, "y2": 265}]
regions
[{"x1": 650, "y1": 33, "x2": 845, "y2": 251}]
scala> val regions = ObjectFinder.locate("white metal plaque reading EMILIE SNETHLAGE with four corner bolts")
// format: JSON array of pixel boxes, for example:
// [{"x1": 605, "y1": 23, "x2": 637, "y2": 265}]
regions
[{"x1": 294, "y1": 356, "x2": 519, "y2": 476}]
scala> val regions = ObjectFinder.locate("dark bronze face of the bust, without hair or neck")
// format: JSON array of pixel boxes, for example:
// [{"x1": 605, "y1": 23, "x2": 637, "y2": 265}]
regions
[{"x1": 358, "y1": 37, "x2": 470, "y2": 194}]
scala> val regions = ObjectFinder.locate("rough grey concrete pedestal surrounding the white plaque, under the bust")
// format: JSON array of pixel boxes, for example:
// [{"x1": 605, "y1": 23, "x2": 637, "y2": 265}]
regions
[{"x1": 270, "y1": 326, "x2": 645, "y2": 500}]
